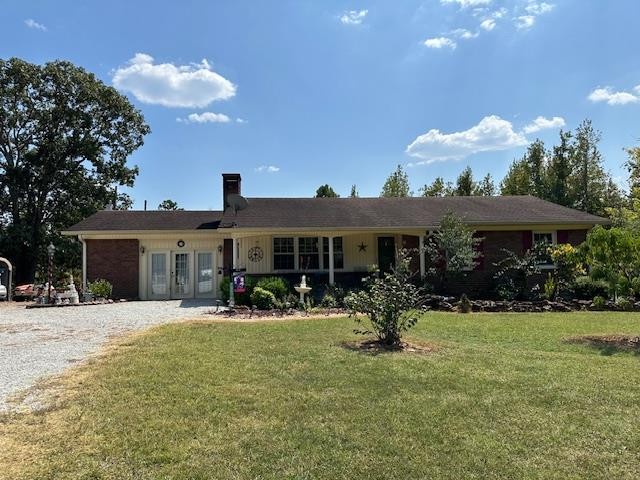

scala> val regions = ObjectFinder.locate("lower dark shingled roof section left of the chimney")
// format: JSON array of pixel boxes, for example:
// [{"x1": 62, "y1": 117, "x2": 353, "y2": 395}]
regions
[{"x1": 67, "y1": 210, "x2": 222, "y2": 232}]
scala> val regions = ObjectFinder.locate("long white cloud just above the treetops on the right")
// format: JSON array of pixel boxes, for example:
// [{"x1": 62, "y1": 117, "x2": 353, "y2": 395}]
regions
[{"x1": 406, "y1": 115, "x2": 528, "y2": 164}]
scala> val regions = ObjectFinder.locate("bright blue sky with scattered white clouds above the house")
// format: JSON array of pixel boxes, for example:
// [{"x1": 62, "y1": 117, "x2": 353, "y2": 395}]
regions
[{"x1": 0, "y1": 0, "x2": 640, "y2": 209}]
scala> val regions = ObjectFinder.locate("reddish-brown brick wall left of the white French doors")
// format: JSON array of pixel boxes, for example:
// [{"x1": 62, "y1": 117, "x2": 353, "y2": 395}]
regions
[{"x1": 87, "y1": 240, "x2": 140, "y2": 299}]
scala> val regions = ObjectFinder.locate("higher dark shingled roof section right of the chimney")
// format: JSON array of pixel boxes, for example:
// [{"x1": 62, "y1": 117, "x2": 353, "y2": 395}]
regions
[{"x1": 223, "y1": 195, "x2": 608, "y2": 228}]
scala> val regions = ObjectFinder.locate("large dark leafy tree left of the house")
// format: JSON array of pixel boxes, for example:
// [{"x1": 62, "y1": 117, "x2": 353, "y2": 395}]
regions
[{"x1": 0, "y1": 58, "x2": 149, "y2": 282}]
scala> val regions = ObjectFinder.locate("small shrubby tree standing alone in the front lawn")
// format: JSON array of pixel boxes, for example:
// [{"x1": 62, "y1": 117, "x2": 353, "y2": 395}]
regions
[{"x1": 345, "y1": 249, "x2": 424, "y2": 348}]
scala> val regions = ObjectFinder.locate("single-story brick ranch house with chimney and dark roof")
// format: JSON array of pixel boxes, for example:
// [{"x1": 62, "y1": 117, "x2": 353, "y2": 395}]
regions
[{"x1": 64, "y1": 174, "x2": 607, "y2": 300}]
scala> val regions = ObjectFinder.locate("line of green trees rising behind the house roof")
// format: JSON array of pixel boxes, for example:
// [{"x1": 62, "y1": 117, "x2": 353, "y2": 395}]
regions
[{"x1": 316, "y1": 120, "x2": 640, "y2": 221}]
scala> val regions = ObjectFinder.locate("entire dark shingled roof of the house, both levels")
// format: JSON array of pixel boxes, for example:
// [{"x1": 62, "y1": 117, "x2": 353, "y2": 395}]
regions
[{"x1": 67, "y1": 196, "x2": 609, "y2": 232}]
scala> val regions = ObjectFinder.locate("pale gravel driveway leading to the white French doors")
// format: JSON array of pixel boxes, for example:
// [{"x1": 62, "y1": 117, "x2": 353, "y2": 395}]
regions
[{"x1": 0, "y1": 300, "x2": 215, "y2": 412}]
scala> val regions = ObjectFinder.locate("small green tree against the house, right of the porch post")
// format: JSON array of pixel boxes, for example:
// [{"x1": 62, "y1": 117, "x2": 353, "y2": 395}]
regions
[{"x1": 425, "y1": 213, "x2": 482, "y2": 289}]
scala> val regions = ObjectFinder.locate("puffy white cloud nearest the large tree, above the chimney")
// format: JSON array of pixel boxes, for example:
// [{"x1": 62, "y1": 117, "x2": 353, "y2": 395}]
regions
[{"x1": 112, "y1": 53, "x2": 236, "y2": 108}]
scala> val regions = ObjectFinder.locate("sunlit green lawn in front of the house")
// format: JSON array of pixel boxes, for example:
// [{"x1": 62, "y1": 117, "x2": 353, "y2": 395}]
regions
[{"x1": 0, "y1": 313, "x2": 640, "y2": 480}]
